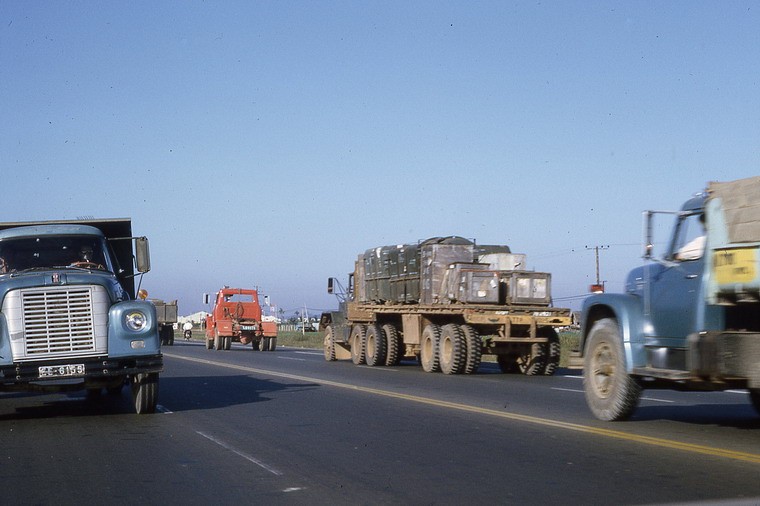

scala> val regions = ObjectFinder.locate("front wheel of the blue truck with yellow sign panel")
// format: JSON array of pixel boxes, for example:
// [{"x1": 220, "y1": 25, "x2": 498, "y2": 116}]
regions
[{"x1": 583, "y1": 318, "x2": 641, "y2": 421}]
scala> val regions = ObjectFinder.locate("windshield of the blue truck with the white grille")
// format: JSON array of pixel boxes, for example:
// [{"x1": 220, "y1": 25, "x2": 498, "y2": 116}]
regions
[{"x1": 0, "y1": 235, "x2": 113, "y2": 273}]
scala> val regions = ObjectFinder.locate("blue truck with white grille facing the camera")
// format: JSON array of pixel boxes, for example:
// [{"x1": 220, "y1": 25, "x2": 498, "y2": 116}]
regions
[{"x1": 0, "y1": 218, "x2": 163, "y2": 414}]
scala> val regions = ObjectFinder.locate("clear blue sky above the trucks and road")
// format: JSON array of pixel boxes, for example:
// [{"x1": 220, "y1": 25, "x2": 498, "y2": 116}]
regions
[{"x1": 0, "y1": 0, "x2": 760, "y2": 314}]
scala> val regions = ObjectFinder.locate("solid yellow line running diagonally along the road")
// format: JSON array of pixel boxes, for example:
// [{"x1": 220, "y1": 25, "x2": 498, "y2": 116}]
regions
[{"x1": 164, "y1": 352, "x2": 760, "y2": 464}]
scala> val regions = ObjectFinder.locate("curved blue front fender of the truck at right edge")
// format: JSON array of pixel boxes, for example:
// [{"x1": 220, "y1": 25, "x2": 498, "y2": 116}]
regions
[{"x1": 580, "y1": 293, "x2": 646, "y2": 372}]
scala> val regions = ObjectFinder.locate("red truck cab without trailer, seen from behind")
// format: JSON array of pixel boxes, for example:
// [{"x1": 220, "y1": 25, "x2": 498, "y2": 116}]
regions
[{"x1": 204, "y1": 286, "x2": 277, "y2": 351}]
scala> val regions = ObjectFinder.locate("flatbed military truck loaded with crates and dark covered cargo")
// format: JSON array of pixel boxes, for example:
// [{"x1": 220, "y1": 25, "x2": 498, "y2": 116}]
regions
[{"x1": 320, "y1": 236, "x2": 571, "y2": 375}]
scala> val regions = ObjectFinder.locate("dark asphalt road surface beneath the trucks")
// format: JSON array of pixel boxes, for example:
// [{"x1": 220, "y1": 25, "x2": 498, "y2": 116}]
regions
[{"x1": 0, "y1": 342, "x2": 760, "y2": 505}]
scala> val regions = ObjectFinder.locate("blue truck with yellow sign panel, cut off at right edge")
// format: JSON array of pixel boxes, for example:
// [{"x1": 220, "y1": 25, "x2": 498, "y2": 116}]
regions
[{"x1": 576, "y1": 177, "x2": 760, "y2": 421}]
